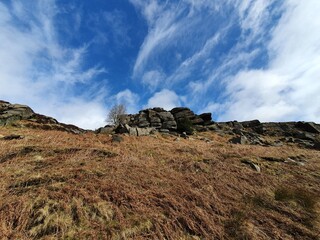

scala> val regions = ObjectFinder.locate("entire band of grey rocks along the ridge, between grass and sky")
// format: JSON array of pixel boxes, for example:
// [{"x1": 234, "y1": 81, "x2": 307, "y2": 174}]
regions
[{"x1": 0, "y1": 101, "x2": 320, "y2": 150}]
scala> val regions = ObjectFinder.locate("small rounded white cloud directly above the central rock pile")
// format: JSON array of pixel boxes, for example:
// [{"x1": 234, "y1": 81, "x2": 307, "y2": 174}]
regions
[{"x1": 145, "y1": 89, "x2": 181, "y2": 110}]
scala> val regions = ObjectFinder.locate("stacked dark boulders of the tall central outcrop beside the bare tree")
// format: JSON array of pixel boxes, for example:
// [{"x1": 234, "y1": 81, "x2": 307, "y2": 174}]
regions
[{"x1": 117, "y1": 107, "x2": 212, "y2": 132}]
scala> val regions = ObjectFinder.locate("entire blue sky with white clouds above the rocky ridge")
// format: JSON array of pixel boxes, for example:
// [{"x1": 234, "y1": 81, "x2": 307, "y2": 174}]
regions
[{"x1": 0, "y1": 0, "x2": 320, "y2": 129}]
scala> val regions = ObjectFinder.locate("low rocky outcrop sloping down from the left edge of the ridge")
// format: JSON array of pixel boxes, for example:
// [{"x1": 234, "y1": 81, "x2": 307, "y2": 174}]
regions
[{"x1": 0, "y1": 100, "x2": 85, "y2": 134}]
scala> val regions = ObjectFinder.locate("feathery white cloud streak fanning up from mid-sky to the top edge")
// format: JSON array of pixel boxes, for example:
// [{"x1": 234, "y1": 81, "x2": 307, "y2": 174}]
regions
[{"x1": 130, "y1": 0, "x2": 207, "y2": 78}]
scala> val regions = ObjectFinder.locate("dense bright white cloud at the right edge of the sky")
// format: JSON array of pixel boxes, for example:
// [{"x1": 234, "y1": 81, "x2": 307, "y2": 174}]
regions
[{"x1": 220, "y1": 0, "x2": 320, "y2": 122}]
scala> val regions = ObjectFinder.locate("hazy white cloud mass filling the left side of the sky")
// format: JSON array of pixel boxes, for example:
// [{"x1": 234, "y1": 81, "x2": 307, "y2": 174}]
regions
[{"x1": 0, "y1": 0, "x2": 106, "y2": 128}]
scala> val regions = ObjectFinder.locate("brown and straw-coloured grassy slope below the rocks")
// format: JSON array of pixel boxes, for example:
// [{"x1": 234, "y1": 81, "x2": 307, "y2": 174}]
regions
[{"x1": 0, "y1": 127, "x2": 320, "y2": 239}]
